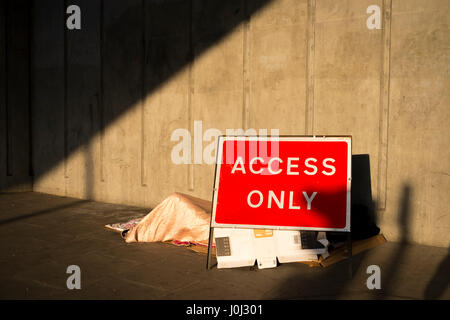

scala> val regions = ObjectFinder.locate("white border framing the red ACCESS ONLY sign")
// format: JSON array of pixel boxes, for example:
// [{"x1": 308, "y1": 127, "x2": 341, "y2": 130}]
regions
[{"x1": 211, "y1": 135, "x2": 352, "y2": 232}]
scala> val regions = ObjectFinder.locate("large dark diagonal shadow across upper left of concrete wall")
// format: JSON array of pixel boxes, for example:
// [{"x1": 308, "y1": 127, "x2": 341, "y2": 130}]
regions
[{"x1": 1, "y1": 0, "x2": 271, "y2": 198}]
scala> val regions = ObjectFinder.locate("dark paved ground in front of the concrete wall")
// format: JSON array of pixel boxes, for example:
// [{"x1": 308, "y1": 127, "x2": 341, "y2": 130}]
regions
[{"x1": 0, "y1": 192, "x2": 450, "y2": 300}]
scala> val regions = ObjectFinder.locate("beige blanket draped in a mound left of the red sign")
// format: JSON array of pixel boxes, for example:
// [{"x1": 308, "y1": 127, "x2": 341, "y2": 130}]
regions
[{"x1": 124, "y1": 193, "x2": 211, "y2": 245}]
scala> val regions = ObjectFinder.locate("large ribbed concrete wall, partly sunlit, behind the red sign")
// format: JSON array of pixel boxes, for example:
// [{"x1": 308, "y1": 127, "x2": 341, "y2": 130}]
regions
[{"x1": 0, "y1": 0, "x2": 450, "y2": 247}]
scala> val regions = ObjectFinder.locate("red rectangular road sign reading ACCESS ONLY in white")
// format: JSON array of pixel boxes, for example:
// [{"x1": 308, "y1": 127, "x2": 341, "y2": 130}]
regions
[{"x1": 211, "y1": 136, "x2": 351, "y2": 231}]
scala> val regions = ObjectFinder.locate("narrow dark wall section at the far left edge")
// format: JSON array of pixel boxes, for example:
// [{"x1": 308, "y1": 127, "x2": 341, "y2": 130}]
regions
[{"x1": 0, "y1": 0, "x2": 32, "y2": 191}]
